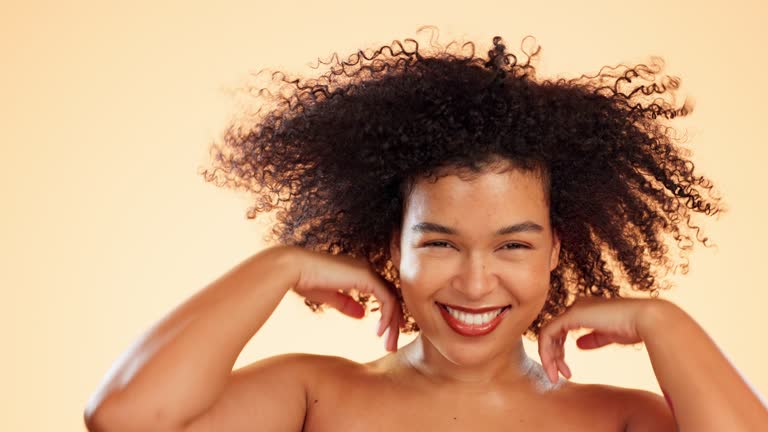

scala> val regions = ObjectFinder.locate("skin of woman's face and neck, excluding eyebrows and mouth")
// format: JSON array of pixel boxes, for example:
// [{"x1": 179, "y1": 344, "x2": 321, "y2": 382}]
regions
[{"x1": 391, "y1": 164, "x2": 560, "y2": 388}]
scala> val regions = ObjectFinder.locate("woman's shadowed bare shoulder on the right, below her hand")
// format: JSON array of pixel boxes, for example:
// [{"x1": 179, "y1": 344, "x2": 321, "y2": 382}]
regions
[{"x1": 569, "y1": 383, "x2": 677, "y2": 432}]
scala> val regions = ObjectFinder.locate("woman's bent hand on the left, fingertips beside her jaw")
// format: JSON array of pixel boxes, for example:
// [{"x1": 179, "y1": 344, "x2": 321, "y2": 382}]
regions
[{"x1": 290, "y1": 246, "x2": 405, "y2": 352}]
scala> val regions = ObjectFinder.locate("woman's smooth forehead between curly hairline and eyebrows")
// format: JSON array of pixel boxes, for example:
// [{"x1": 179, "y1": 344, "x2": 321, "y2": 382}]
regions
[{"x1": 404, "y1": 169, "x2": 549, "y2": 225}]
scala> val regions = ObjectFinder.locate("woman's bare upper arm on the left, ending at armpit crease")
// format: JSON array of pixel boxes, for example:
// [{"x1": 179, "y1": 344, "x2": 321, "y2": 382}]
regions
[{"x1": 182, "y1": 354, "x2": 313, "y2": 432}]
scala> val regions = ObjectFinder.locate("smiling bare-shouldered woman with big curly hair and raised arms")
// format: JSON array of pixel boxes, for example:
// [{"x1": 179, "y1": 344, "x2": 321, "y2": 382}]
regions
[{"x1": 85, "y1": 28, "x2": 768, "y2": 432}]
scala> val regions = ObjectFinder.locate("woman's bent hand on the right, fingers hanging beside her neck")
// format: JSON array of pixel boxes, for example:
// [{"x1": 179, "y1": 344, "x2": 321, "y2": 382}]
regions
[{"x1": 538, "y1": 297, "x2": 664, "y2": 383}]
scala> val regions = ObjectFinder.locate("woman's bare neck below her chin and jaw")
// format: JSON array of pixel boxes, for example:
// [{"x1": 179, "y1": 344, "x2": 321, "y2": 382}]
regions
[{"x1": 397, "y1": 334, "x2": 536, "y2": 390}]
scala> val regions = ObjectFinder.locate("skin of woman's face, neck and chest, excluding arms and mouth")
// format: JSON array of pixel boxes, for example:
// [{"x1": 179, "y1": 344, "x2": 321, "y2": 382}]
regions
[{"x1": 305, "y1": 164, "x2": 674, "y2": 432}]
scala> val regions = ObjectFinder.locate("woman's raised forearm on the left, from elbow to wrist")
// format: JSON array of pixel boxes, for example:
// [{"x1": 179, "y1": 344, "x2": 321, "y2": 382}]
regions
[{"x1": 84, "y1": 247, "x2": 303, "y2": 431}]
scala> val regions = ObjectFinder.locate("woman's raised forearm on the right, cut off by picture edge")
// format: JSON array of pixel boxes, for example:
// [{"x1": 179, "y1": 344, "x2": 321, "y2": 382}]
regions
[{"x1": 627, "y1": 301, "x2": 768, "y2": 432}]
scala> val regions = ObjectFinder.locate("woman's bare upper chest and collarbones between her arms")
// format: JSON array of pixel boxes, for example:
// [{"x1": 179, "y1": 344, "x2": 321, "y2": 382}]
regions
[{"x1": 296, "y1": 355, "x2": 656, "y2": 432}]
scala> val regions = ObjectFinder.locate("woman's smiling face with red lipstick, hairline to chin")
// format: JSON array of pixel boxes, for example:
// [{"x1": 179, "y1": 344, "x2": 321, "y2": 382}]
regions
[{"x1": 391, "y1": 165, "x2": 560, "y2": 365}]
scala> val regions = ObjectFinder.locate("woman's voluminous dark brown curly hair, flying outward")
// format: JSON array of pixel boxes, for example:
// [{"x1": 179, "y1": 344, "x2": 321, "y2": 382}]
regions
[{"x1": 201, "y1": 28, "x2": 725, "y2": 339}]
